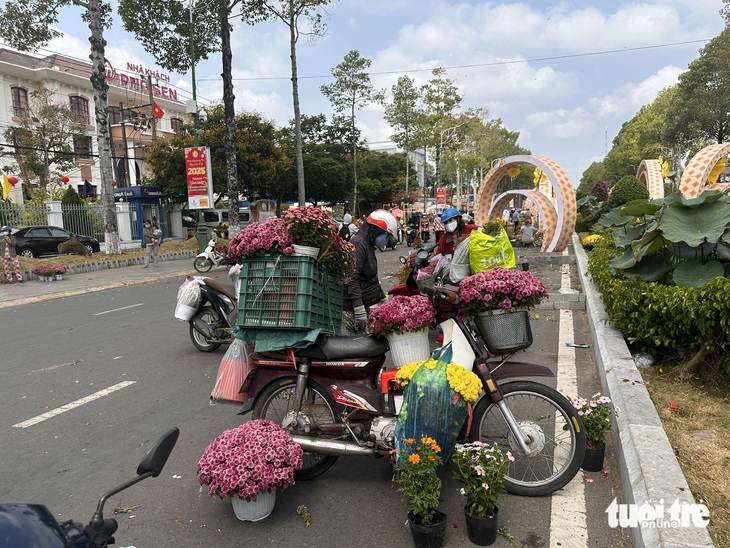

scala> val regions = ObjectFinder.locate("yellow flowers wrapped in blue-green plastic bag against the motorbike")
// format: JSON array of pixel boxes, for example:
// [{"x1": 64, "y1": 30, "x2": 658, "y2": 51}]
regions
[{"x1": 395, "y1": 344, "x2": 482, "y2": 465}]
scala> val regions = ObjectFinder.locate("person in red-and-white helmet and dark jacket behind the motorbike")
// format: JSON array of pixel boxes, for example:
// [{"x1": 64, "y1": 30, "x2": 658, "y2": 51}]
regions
[{"x1": 343, "y1": 209, "x2": 398, "y2": 335}]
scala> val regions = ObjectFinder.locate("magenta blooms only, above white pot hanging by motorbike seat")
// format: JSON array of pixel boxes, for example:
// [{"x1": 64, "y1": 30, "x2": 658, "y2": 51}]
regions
[{"x1": 367, "y1": 295, "x2": 436, "y2": 335}]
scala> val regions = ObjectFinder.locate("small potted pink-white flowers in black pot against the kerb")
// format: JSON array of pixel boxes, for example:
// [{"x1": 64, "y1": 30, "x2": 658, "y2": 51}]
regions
[{"x1": 571, "y1": 393, "x2": 618, "y2": 472}]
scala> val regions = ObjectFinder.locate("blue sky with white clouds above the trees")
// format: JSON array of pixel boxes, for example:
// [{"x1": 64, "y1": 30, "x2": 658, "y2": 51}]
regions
[{"x1": 7, "y1": 0, "x2": 724, "y2": 187}]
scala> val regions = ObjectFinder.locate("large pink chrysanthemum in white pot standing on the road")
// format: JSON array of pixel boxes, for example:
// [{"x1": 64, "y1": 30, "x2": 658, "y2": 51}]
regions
[{"x1": 196, "y1": 419, "x2": 304, "y2": 521}]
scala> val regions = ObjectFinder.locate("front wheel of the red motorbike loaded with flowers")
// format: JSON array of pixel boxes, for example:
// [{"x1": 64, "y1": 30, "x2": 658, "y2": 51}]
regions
[{"x1": 469, "y1": 381, "x2": 586, "y2": 497}]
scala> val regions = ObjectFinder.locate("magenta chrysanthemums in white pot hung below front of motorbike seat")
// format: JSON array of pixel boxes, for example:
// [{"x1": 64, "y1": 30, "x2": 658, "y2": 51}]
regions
[{"x1": 367, "y1": 295, "x2": 436, "y2": 366}]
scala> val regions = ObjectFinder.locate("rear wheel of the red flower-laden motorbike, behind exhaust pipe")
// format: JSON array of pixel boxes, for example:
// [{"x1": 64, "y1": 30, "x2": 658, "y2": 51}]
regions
[{"x1": 252, "y1": 378, "x2": 340, "y2": 480}]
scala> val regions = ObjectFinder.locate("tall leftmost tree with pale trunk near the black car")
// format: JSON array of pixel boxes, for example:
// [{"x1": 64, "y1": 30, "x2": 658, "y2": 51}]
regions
[{"x1": 0, "y1": 0, "x2": 121, "y2": 254}]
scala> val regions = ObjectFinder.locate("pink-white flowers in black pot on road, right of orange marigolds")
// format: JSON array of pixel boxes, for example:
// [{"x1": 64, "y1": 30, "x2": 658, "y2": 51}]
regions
[{"x1": 452, "y1": 441, "x2": 515, "y2": 546}]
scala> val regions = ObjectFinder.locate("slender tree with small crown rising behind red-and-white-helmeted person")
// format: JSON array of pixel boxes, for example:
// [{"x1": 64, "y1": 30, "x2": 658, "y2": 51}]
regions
[{"x1": 319, "y1": 50, "x2": 385, "y2": 216}]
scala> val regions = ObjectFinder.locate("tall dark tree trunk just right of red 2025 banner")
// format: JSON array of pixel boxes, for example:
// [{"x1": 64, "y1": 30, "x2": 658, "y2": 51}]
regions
[{"x1": 219, "y1": 2, "x2": 240, "y2": 236}]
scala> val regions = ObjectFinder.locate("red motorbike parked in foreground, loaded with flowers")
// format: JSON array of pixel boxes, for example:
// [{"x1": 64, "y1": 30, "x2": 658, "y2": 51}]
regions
[{"x1": 240, "y1": 249, "x2": 586, "y2": 496}]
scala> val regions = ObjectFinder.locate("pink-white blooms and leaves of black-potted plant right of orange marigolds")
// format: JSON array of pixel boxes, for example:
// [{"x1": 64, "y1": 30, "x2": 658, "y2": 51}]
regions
[{"x1": 452, "y1": 441, "x2": 515, "y2": 518}]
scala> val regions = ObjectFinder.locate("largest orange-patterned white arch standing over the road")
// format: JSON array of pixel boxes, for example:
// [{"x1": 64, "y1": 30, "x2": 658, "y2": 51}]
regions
[{"x1": 474, "y1": 155, "x2": 577, "y2": 251}]
